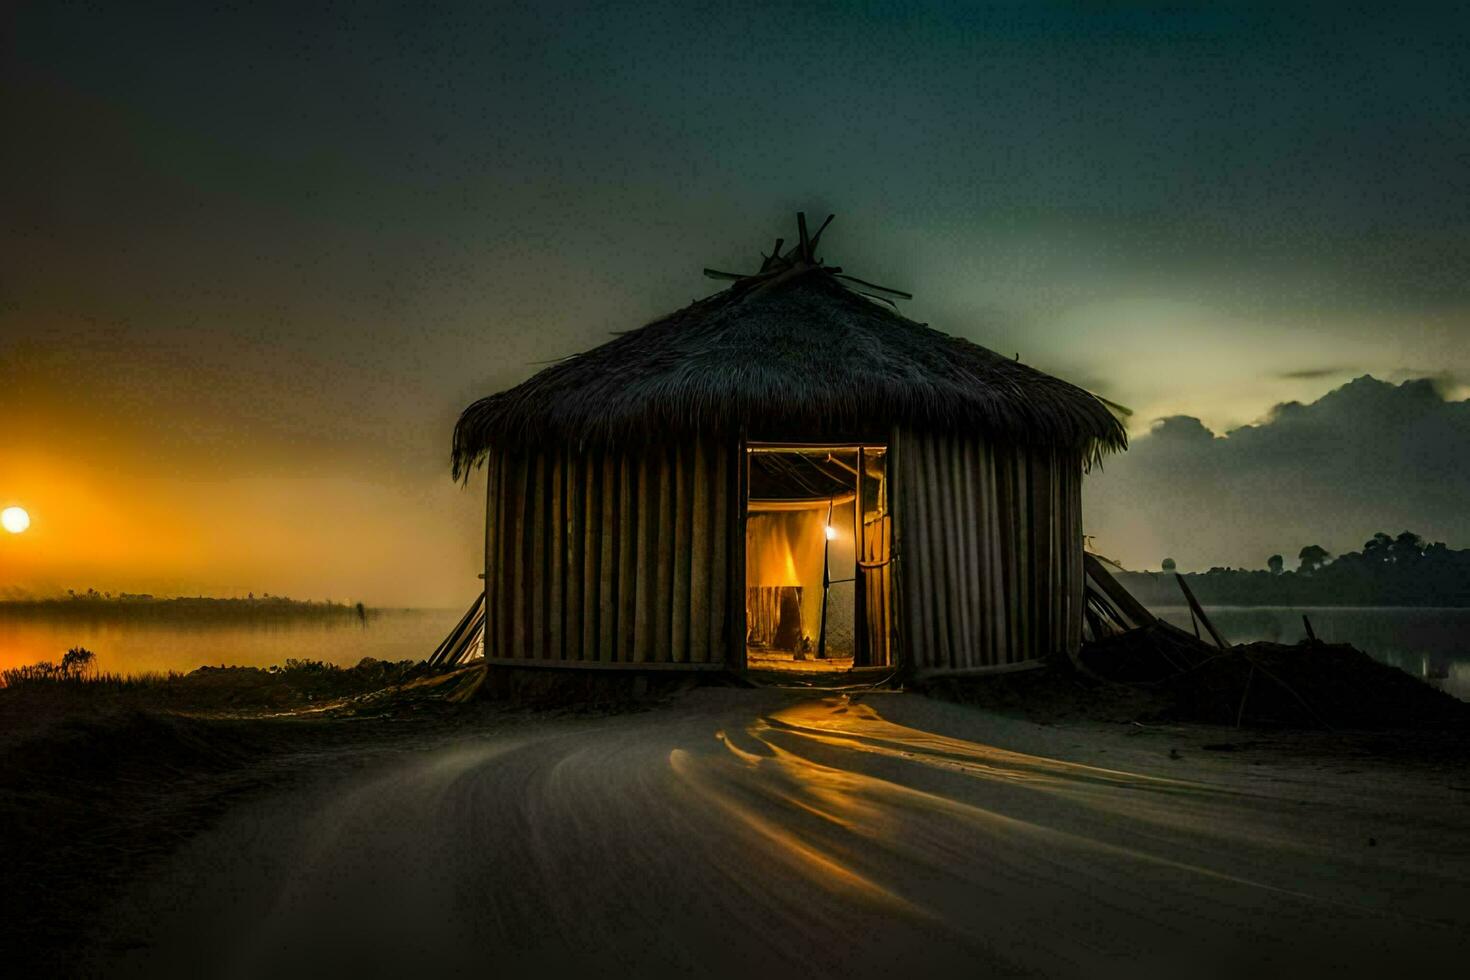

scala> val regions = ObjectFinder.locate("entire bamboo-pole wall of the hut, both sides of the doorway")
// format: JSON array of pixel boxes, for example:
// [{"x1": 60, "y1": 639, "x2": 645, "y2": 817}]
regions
[{"x1": 485, "y1": 432, "x2": 1083, "y2": 674}]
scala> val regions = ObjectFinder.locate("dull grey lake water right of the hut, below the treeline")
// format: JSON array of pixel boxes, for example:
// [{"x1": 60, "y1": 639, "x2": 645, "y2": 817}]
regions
[{"x1": 1152, "y1": 605, "x2": 1470, "y2": 701}]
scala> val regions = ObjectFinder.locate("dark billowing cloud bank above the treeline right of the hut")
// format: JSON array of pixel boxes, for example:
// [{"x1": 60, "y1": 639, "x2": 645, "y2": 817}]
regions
[{"x1": 1085, "y1": 375, "x2": 1470, "y2": 569}]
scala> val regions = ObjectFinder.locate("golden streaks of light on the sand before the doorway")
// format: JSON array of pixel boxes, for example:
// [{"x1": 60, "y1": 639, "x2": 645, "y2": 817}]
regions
[{"x1": 669, "y1": 695, "x2": 1381, "y2": 918}]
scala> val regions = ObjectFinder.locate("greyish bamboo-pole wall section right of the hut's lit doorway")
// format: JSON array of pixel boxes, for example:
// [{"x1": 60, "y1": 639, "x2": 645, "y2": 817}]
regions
[{"x1": 889, "y1": 432, "x2": 1083, "y2": 674}]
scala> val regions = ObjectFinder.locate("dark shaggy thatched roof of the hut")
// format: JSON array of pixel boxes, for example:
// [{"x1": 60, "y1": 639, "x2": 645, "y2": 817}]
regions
[{"x1": 453, "y1": 222, "x2": 1127, "y2": 476}]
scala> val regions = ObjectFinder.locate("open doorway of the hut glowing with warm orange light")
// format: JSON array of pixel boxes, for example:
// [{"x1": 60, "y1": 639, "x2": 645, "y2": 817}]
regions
[{"x1": 745, "y1": 444, "x2": 892, "y2": 673}]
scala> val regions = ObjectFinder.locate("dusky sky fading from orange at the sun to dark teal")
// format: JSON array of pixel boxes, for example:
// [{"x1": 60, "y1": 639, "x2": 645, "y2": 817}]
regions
[{"x1": 0, "y1": 1, "x2": 1470, "y2": 605}]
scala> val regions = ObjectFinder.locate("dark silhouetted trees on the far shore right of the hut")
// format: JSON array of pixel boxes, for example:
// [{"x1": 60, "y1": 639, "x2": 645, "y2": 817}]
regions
[{"x1": 1119, "y1": 530, "x2": 1470, "y2": 607}]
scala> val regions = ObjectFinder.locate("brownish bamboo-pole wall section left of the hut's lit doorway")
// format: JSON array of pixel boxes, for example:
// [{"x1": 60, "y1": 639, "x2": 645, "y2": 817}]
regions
[{"x1": 485, "y1": 441, "x2": 744, "y2": 669}]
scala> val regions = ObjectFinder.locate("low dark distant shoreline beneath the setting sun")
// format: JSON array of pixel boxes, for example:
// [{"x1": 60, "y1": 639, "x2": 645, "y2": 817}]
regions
[{"x1": 0, "y1": 589, "x2": 369, "y2": 620}]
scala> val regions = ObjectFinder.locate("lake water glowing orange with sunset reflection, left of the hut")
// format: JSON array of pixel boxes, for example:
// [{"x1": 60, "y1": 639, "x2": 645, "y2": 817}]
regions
[{"x1": 0, "y1": 607, "x2": 465, "y2": 674}]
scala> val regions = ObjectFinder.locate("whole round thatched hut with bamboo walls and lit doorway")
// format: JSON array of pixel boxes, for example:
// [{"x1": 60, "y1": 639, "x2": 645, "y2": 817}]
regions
[{"x1": 453, "y1": 219, "x2": 1126, "y2": 676}]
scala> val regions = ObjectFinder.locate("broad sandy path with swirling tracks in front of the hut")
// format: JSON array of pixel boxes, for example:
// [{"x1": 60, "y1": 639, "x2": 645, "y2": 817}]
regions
[{"x1": 100, "y1": 691, "x2": 1470, "y2": 977}]
